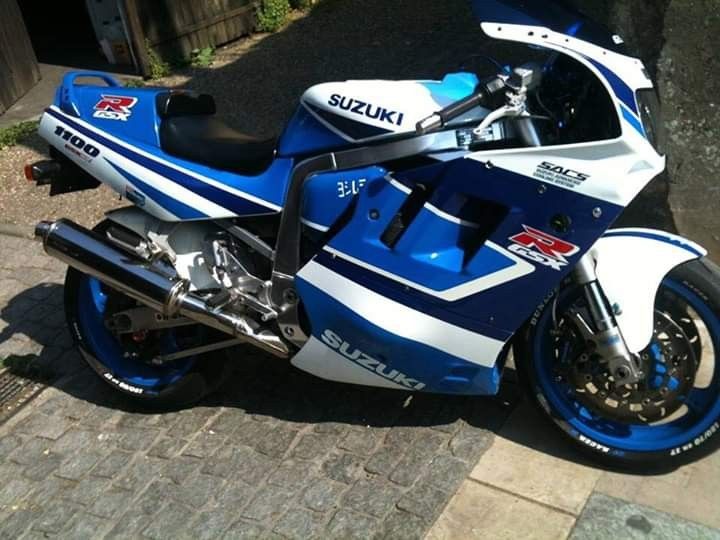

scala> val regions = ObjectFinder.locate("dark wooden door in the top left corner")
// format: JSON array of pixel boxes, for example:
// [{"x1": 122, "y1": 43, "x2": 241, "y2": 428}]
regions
[{"x1": 0, "y1": 0, "x2": 40, "y2": 114}]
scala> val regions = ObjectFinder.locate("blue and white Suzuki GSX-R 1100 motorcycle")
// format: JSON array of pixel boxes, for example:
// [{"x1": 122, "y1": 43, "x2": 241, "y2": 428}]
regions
[{"x1": 28, "y1": 0, "x2": 720, "y2": 466}]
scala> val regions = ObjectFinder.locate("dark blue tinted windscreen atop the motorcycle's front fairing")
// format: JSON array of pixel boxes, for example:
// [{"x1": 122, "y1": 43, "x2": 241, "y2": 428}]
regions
[{"x1": 471, "y1": 0, "x2": 626, "y2": 54}]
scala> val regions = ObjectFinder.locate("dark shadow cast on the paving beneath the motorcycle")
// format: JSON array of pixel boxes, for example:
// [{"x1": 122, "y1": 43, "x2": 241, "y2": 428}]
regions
[{"x1": 0, "y1": 284, "x2": 667, "y2": 474}]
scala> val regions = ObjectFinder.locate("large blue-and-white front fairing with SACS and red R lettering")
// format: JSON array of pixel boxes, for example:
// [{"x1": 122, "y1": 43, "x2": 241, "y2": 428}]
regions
[{"x1": 294, "y1": 0, "x2": 679, "y2": 394}]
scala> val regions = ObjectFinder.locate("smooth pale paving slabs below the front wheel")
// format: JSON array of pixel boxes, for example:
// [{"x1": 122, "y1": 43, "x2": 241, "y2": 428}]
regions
[{"x1": 427, "y1": 403, "x2": 720, "y2": 540}]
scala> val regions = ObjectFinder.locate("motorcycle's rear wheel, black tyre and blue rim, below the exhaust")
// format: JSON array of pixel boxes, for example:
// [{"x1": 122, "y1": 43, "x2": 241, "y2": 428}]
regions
[{"x1": 65, "y1": 219, "x2": 229, "y2": 409}]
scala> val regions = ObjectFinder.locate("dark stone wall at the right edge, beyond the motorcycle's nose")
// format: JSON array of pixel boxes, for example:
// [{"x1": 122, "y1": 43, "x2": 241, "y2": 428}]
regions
[{"x1": 658, "y1": 0, "x2": 720, "y2": 262}]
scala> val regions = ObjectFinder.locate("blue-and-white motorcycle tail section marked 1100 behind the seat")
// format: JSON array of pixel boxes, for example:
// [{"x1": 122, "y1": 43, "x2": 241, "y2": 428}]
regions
[{"x1": 39, "y1": 72, "x2": 293, "y2": 222}]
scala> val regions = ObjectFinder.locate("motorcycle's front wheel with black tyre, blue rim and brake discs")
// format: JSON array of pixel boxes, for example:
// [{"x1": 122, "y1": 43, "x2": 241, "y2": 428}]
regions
[{"x1": 517, "y1": 261, "x2": 720, "y2": 469}]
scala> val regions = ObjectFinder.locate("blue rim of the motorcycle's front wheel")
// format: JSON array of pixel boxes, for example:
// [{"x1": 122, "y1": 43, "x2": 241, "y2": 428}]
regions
[{"x1": 532, "y1": 278, "x2": 720, "y2": 452}]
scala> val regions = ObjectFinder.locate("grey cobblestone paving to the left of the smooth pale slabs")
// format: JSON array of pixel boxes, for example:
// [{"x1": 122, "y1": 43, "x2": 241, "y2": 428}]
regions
[{"x1": 0, "y1": 236, "x2": 512, "y2": 539}]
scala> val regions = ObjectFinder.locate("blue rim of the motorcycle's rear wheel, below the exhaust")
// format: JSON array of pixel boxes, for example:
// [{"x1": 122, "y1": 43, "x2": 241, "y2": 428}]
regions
[{"x1": 77, "y1": 275, "x2": 194, "y2": 392}]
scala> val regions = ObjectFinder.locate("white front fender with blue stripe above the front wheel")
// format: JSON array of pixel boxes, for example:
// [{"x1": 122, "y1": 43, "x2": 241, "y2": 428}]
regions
[{"x1": 591, "y1": 229, "x2": 707, "y2": 353}]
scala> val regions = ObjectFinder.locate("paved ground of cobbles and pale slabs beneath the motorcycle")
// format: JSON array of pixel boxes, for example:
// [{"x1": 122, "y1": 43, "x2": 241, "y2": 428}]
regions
[{"x1": 0, "y1": 235, "x2": 720, "y2": 540}]
